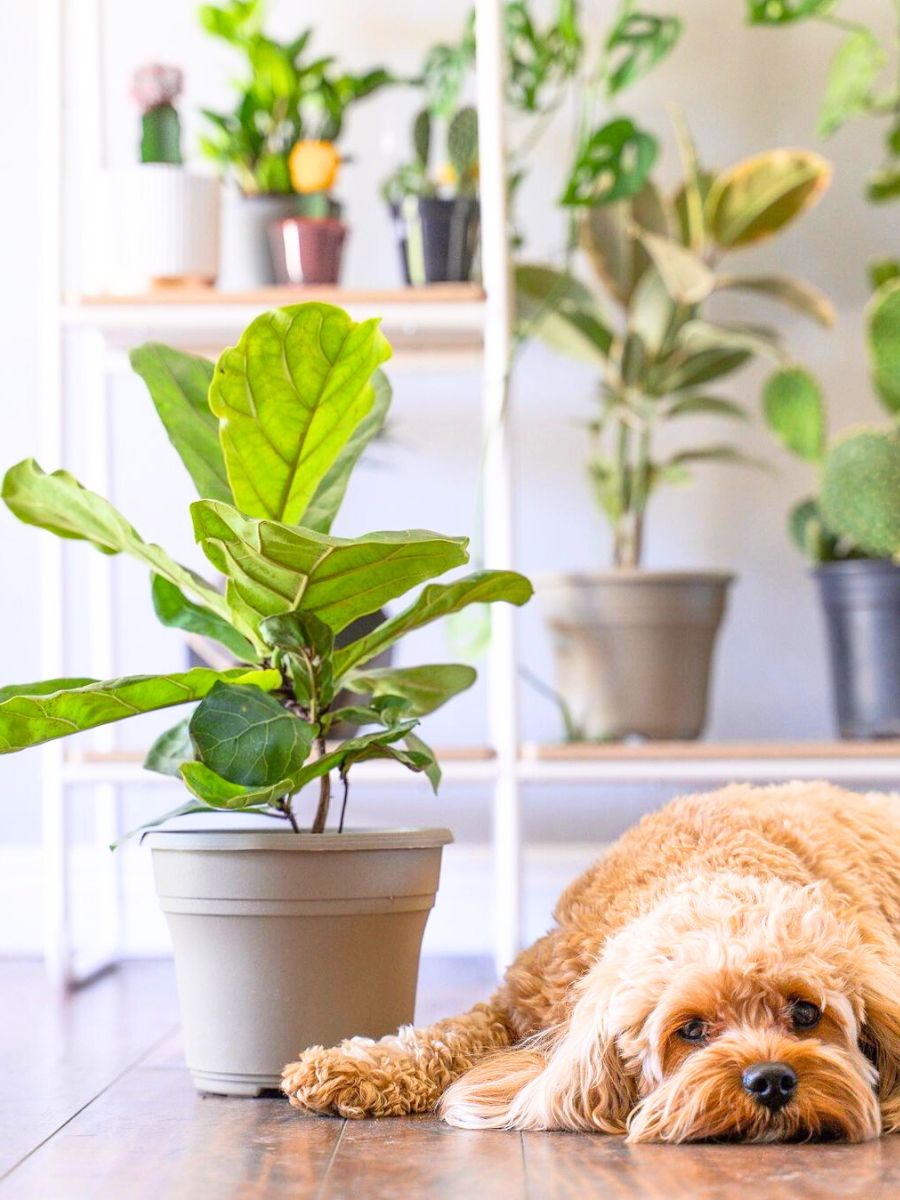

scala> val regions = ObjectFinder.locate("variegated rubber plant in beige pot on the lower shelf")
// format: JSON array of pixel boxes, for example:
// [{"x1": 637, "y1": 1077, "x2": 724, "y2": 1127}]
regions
[{"x1": 517, "y1": 124, "x2": 833, "y2": 738}]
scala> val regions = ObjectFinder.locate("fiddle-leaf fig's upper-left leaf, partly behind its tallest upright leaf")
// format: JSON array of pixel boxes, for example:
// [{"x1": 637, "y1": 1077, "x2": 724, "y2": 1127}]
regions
[{"x1": 128, "y1": 342, "x2": 232, "y2": 504}]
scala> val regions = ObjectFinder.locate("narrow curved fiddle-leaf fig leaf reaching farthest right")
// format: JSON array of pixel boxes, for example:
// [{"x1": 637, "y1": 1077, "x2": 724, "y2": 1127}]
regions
[{"x1": 335, "y1": 571, "x2": 534, "y2": 683}]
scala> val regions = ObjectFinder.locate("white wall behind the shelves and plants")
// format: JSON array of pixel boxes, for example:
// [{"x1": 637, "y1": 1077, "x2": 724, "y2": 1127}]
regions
[{"x1": 0, "y1": 0, "x2": 896, "y2": 949}]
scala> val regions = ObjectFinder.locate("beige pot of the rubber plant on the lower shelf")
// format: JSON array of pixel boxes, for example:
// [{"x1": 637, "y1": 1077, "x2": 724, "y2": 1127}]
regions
[{"x1": 538, "y1": 570, "x2": 733, "y2": 739}]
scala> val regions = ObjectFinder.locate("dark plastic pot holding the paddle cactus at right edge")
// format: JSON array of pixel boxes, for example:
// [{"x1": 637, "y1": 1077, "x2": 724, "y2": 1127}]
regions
[{"x1": 814, "y1": 559, "x2": 900, "y2": 738}]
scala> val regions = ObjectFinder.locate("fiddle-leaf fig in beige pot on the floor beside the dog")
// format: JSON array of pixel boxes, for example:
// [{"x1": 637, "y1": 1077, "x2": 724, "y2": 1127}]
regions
[{"x1": 0, "y1": 304, "x2": 532, "y2": 1094}]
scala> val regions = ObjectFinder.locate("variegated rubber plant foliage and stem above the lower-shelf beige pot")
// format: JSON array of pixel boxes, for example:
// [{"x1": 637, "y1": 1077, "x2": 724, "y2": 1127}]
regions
[{"x1": 516, "y1": 122, "x2": 834, "y2": 566}]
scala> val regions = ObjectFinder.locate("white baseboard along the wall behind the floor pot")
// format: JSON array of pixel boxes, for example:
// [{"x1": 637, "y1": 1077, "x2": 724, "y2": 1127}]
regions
[{"x1": 0, "y1": 842, "x2": 605, "y2": 958}]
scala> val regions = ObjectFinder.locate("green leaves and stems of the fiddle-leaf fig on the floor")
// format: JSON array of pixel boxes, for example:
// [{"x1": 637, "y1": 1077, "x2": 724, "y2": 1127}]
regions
[{"x1": 0, "y1": 304, "x2": 532, "y2": 833}]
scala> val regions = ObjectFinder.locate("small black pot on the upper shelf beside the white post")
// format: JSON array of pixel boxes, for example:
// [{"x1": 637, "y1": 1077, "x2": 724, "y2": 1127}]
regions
[{"x1": 391, "y1": 196, "x2": 481, "y2": 287}]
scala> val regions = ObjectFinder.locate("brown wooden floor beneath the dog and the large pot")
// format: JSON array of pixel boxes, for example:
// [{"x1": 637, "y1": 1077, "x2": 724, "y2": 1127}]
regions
[{"x1": 0, "y1": 960, "x2": 900, "y2": 1200}]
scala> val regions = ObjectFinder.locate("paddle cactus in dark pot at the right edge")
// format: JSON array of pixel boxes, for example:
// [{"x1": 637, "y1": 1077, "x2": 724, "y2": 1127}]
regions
[{"x1": 763, "y1": 280, "x2": 900, "y2": 738}]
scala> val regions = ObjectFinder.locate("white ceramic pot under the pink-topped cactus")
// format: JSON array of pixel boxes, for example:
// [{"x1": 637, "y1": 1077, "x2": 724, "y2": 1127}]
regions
[{"x1": 101, "y1": 162, "x2": 221, "y2": 293}]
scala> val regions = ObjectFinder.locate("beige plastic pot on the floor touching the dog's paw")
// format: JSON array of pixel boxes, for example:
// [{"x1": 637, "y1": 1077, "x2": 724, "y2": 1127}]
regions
[{"x1": 150, "y1": 829, "x2": 452, "y2": 1096}]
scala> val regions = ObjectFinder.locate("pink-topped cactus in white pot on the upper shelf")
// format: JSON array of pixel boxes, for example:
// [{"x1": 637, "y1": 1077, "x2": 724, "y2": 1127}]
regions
[{"x1": 104, "y1": 64, "x2": 220, "y2": 292}]
